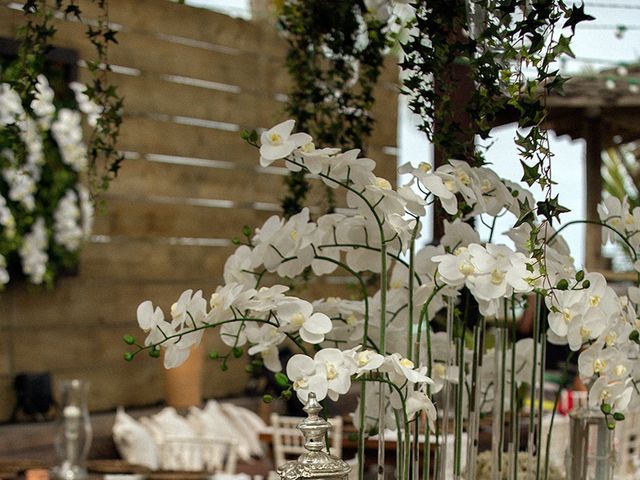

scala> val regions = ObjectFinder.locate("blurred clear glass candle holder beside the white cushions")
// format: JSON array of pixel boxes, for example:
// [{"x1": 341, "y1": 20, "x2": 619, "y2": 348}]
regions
[{"x1": 52, "y1": 379, "x2": 92, "y2": 480}]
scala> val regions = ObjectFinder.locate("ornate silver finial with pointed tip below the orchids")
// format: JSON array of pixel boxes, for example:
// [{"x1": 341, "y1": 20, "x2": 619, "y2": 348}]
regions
[{"x1": 277, "y1": 392, "x2": 351, "y2": 480}]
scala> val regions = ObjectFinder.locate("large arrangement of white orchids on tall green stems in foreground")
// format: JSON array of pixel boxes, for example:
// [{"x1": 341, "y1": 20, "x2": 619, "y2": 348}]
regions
[{"x1": 125, "y1": 120, "x2": 640, "y2": 478}]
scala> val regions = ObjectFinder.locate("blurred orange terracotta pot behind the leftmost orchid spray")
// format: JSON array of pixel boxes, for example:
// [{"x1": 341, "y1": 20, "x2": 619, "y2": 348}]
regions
[{"x1": 164, "y1": 345, "x2": 204, "y2": 409}]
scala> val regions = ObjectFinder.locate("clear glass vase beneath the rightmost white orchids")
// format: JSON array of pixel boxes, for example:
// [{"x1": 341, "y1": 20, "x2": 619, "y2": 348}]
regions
[{"x1": 566, "y1": 407, "x2": 616, "y2": 480}]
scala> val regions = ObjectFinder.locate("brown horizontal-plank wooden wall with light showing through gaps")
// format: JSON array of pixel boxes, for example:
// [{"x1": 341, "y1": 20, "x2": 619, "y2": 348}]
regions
[{"x1": 0, "y1": 0, "x2": 397, "y2": 421}]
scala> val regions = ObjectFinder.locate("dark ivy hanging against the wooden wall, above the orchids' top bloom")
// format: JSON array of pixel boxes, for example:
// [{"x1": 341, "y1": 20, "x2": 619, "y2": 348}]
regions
[{"x1": 279, "y1": 0, "x2": 387, "y2": 216}]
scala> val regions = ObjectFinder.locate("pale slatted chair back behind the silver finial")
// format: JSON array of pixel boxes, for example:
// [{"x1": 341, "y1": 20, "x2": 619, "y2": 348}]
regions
[{"x1": 271, "y1": 413, "x2": 342, "y2": 468}]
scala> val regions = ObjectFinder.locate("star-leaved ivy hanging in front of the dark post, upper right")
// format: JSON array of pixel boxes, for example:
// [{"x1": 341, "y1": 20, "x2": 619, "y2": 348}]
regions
[{"x1": 402, "y1": 0, "x2": 593, "y2": 268}]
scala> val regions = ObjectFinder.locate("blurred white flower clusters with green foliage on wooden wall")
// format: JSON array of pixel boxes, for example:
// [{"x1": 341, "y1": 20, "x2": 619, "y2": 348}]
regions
[{"x1": 0, "y1": 75, "x2": 100, "y2": 287}]
